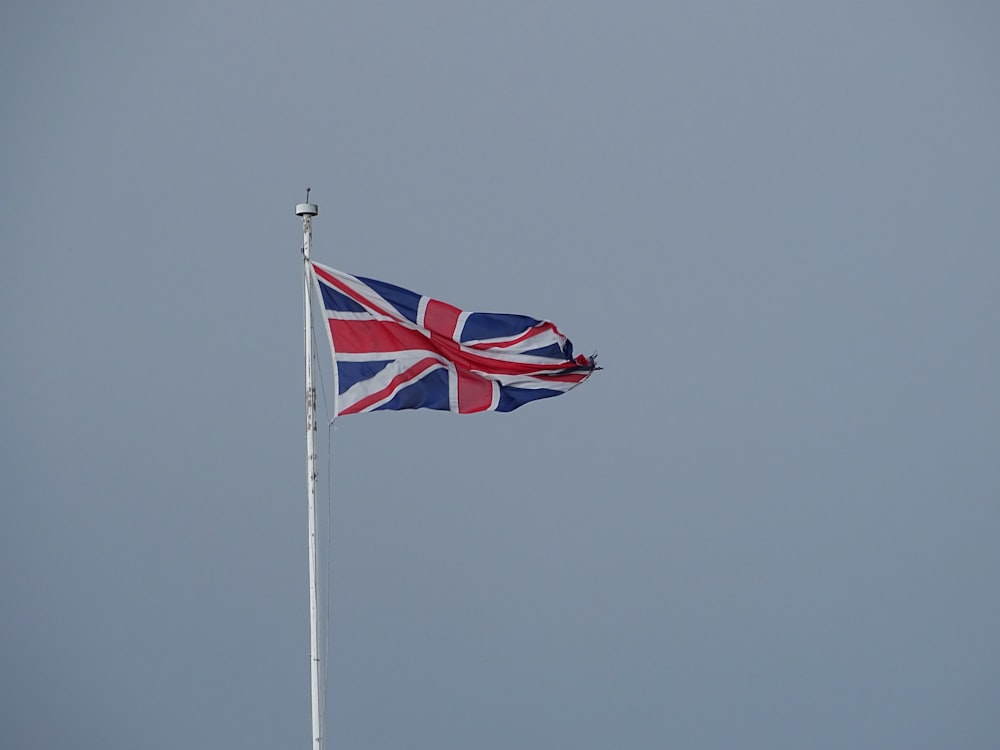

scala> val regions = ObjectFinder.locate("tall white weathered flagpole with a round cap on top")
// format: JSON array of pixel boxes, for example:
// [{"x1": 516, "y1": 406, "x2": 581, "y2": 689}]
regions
[{"x1": 295, "y1": 188, "x2": 323, "y2": 750}]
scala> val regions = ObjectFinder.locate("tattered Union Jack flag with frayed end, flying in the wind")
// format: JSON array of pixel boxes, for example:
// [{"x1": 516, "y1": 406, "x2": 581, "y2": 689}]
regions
[{"x1": 312, "y1": 263, "x2": 596, "y2": 416}]
